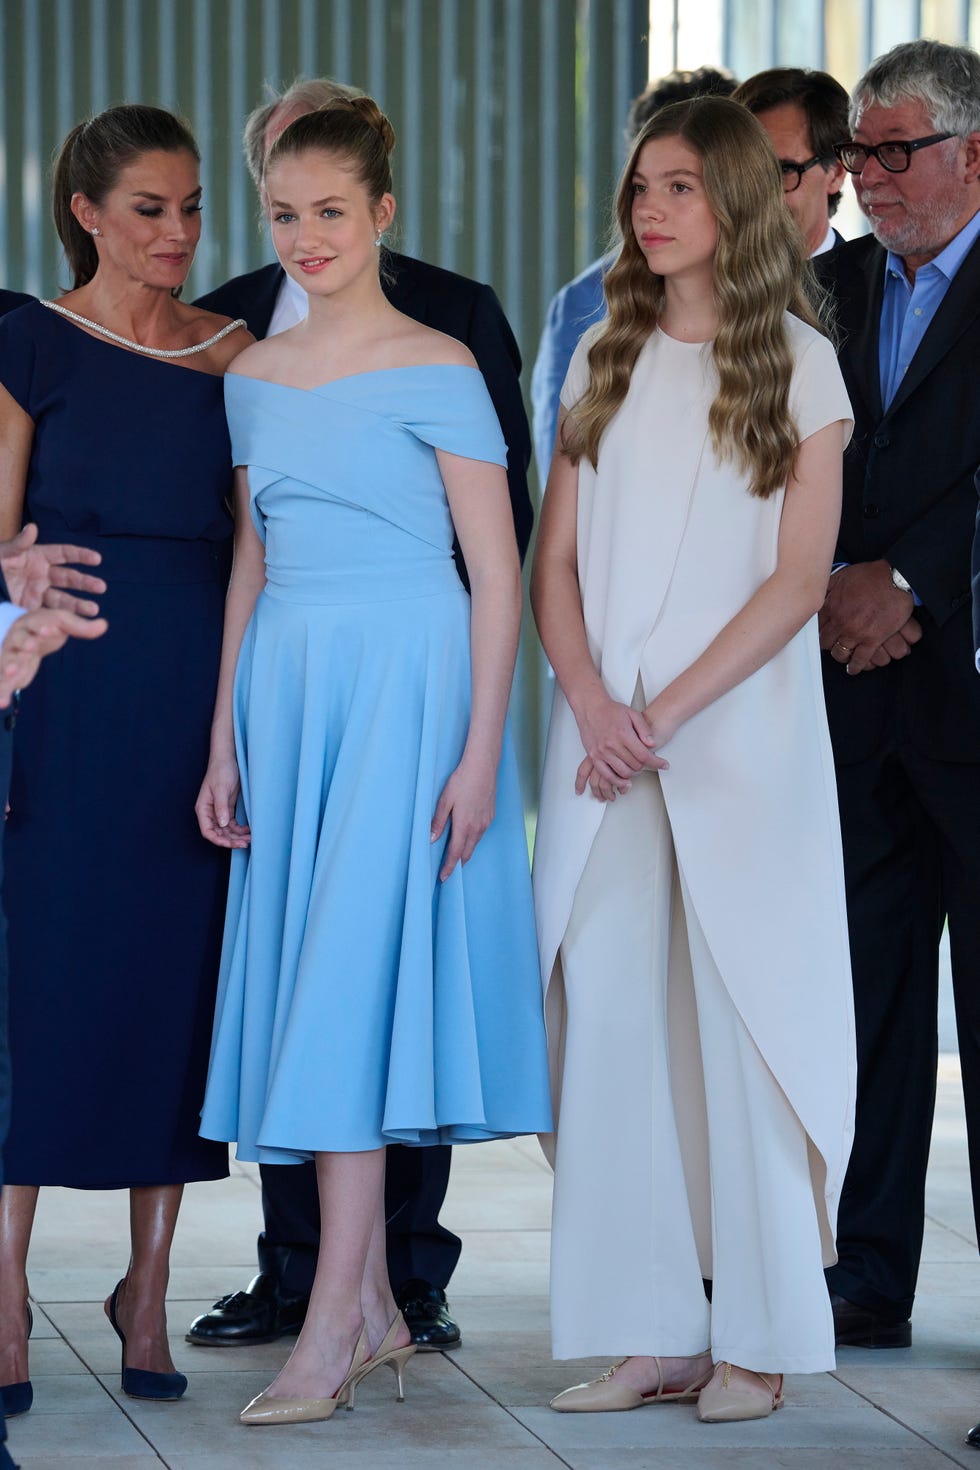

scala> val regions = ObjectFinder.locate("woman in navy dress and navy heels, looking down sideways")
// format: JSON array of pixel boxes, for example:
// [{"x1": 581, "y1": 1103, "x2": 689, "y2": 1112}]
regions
[{"x1": 0, "y1": 106, "x2": 250, "y2": 1410}]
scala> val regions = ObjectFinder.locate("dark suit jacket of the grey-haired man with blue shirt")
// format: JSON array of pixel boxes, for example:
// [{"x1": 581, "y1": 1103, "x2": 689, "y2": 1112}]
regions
[{"x1": 815, "y1": 235, "x2": 980, "y2": 764}]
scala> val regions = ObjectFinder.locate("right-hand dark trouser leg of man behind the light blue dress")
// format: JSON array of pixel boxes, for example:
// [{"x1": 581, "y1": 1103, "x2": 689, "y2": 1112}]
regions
[{"x1": 385, "y1": 1144, "x2": 463, "y2": 1295}]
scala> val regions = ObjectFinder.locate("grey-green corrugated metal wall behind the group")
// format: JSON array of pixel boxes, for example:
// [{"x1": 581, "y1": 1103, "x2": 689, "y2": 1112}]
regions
[{"x1": 0, "y1": 0, "x2": 648, "y2": 795}]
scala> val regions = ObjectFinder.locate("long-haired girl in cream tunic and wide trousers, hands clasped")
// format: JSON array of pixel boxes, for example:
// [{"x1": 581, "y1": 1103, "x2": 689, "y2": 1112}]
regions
[{"x1": 532, "y1": 98, "x2": 854, "y2": 1420}]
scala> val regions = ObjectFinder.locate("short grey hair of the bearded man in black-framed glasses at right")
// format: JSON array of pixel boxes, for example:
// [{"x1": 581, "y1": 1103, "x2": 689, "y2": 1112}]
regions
[{"x1": 849, "y1": 41, "x2": 980, "y2": 138}]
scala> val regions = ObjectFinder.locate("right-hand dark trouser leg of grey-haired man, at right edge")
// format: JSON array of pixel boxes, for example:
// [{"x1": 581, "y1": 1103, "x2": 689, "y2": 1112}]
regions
[{"x1": 908, "y1": 759, "x2": 980, "y2": 1246}]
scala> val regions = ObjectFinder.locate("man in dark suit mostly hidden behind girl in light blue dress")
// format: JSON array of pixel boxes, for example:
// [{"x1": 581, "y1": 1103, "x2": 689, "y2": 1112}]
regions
[{"x1": 188, "y1": 78, "x2": 532, "y2": 1349}]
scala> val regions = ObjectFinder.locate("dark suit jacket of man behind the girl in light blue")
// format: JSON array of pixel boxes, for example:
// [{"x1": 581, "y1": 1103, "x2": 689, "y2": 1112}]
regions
[{"x1": 198, "y1": 251, "x2": 533, "y2": 582}]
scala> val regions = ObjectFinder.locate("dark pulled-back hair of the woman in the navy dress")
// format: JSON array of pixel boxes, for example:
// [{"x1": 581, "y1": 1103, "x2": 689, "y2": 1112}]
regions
[{"x1": 51, "y1": 103, "x2": 201, "y2": 290}]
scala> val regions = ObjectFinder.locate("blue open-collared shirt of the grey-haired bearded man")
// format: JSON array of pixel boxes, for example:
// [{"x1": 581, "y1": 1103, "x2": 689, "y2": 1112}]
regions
[{"x1": 879, "y1": 212, "x2": 980, "y2": 409}]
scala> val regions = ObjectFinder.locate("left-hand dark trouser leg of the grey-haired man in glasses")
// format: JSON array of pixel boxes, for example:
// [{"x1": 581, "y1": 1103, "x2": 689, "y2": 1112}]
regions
[{"x1": 827, "y1": 750, "x2": 942, "y2": 1320}]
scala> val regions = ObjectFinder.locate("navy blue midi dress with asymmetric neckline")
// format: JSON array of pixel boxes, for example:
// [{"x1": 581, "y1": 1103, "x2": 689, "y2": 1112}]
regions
[{"x1": 0, "y1": 303, "x2": 232, "y2": 1189}]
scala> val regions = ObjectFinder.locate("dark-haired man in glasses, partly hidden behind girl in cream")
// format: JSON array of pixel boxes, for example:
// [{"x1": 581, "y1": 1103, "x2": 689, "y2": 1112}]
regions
[{"x1": 732, "y1": 66, "x2": 848, "y2": 256}]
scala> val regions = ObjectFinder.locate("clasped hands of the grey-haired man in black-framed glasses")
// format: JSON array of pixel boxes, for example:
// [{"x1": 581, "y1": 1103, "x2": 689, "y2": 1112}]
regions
[{"x1": 820, "y1": 562, "x2": 921, "y2": 673}]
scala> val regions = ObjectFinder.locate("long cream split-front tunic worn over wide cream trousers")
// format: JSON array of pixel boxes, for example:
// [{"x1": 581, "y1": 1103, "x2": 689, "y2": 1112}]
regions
[{"x1": 535, "y1": 316, "x2": 855, "y2": 1264}]
